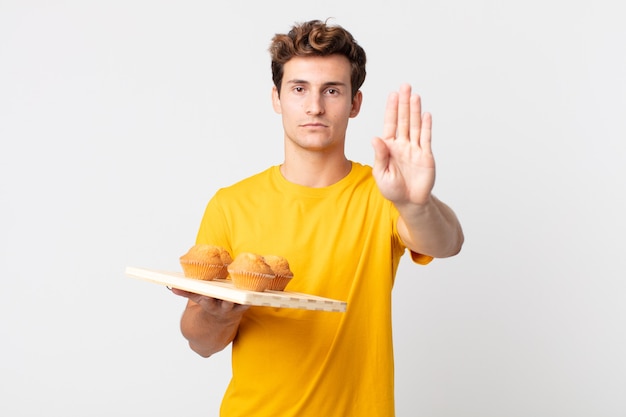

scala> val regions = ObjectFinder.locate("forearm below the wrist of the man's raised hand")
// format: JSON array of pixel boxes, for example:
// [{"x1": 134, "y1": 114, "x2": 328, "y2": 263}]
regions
[{"x1": 396, "y1": 195, "x2": 464, "y2": 258}]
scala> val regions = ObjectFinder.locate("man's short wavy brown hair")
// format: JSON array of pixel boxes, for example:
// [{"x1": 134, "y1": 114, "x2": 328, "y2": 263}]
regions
[{"x1": 269, "y1": 20, "x2": 366, "y2": 98}]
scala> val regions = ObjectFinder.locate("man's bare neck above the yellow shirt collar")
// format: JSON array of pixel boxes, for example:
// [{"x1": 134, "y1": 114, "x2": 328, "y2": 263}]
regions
[{"x1": 280, "y1": 154, "x2": 352, "y2": 188}]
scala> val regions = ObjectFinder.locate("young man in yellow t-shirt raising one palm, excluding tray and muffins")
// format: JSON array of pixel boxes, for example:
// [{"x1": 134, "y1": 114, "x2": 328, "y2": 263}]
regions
[{"x1": 173, "y1": 21, "x2": 463, "y2": 417}]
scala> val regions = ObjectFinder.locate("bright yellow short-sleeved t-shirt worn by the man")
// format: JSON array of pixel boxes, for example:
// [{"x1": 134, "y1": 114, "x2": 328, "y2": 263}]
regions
[{"x1": 197, "y1": 163, "x2": 432, "y2": 417}]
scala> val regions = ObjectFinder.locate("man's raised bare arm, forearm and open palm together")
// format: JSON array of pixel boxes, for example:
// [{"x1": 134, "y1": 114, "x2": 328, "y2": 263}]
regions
[{"x1": 372, "y1": 85, "x2": 464, "y2": 258}]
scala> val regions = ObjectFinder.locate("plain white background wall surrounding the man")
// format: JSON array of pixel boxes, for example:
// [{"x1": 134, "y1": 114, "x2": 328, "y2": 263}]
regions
[{"x1": 0, "y1": 0, "x2": 626, "y2": 417}]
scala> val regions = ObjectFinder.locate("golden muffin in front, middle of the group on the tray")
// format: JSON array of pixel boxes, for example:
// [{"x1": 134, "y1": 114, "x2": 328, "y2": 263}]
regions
[{"x1": 227, "y1": 252, "x2": 274, "y2": 291}]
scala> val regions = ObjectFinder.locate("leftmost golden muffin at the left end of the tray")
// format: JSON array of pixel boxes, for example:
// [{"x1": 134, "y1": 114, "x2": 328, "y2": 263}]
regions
[{"x1": 180, "y1": 244, "x2": 230, "y2": 281}]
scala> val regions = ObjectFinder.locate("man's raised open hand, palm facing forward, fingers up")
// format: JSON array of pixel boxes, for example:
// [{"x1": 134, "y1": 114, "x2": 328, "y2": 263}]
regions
[{"x1": 372, "y1": 84, "x2": 435, "y2": 206}]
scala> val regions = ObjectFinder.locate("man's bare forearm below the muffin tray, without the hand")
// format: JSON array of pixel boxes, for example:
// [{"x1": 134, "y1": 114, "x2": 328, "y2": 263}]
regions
[{"x1": 180, "y1": 301, "x2": 241, "y2": 358}]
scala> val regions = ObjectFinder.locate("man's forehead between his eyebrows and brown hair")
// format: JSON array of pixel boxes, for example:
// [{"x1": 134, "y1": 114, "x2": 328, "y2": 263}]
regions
[{"x1": 283, "y1": 55, "x2": 351, "y2": 84}]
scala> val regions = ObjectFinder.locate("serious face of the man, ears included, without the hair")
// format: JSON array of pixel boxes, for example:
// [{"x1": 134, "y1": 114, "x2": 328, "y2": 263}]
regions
[{"x1": 272, "y1": 55, "x2": 362, "y2": 152}]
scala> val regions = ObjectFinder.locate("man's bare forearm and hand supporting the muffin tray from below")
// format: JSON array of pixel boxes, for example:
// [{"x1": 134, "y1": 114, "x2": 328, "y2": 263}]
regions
[{"x1": 172, "y1": 288, "x2": 249, "y2": 358}]
